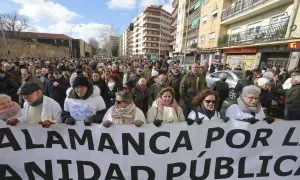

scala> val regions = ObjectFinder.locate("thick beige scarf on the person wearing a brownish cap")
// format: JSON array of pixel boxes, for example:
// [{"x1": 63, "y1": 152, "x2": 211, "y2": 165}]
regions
[{"x1": 111, "y1": 103, "x2": 136, "y2": 124}]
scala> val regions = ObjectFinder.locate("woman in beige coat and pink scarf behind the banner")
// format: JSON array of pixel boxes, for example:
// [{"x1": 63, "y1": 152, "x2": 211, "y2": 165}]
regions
[{"x1": 147, "y1": 87, "x2": 185, "y2": 126}]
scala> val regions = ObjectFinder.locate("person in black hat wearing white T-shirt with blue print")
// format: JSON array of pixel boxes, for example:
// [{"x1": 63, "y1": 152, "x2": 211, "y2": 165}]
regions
[{"x1": 62, "y1": 75, "x2": 106, "y2": 126}]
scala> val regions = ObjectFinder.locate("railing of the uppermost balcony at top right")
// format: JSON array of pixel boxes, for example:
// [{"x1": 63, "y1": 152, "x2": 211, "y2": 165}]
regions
[{"x1": 222, "y1": 0, "x2": 270, "y2": 21}]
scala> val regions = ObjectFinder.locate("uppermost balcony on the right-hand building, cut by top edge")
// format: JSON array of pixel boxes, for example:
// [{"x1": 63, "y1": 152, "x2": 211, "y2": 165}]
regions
[{"x1": 221, "y1": 0, "x2": 294, "y2": 25}]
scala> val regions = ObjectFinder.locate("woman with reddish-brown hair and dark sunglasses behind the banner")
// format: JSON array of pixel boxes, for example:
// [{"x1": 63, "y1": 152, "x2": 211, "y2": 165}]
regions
[{"x1": 187, "y1": 90, "x2": 220, "y2": 125}]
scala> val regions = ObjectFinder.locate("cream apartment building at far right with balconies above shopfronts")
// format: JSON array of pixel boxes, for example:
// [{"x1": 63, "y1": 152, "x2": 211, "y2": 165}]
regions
[{"x1": 219, "y1": 0, "x2": 300, "y2": 69}]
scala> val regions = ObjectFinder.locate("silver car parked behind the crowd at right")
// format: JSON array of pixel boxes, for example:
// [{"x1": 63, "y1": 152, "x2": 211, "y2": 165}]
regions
[{"x1": 206, "y1": 70, "x2": 243, "y2": 99}]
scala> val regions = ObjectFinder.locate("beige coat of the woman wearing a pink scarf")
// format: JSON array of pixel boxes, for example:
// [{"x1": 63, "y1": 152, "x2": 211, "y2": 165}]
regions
[{"x1": 147, "y1": 100, "x2": 185, "y2": 123}]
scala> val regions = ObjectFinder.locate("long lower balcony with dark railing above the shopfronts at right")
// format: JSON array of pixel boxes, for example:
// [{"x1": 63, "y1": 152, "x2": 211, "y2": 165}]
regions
[{"x1": 219, "y1": 21, "x2": 288, "y2": 47}]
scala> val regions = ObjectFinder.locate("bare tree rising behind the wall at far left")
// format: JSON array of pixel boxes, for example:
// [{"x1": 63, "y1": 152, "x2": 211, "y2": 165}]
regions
[{"x1": 0, "y1": 11, "x2": 30, "y2": 35}]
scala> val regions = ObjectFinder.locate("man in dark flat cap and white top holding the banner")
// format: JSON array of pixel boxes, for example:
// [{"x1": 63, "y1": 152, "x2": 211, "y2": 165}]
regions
[{"x1": 7, "y1": 83, "x2": 62, "y2": 128}]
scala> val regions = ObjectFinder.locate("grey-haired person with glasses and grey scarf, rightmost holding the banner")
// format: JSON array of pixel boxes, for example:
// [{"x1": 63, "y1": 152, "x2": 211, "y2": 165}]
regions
[{"x1": 226, "y1": 85, "x2": 265, "y2": 124}]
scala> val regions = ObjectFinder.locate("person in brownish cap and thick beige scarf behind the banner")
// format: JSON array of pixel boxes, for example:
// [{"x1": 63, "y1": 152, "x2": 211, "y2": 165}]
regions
[{"x1": 102, "y1": 91, "x2": 146, "y2": 128}]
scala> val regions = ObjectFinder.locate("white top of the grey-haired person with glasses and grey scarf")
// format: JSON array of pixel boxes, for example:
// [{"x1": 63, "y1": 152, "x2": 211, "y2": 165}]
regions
[{"x1": 225, "y1": 104, "x2": 265, "y2": 120}]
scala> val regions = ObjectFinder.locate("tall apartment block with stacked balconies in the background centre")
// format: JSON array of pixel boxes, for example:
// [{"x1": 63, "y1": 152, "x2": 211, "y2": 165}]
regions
[{"x1": 126, "y1": 6, "x2": 172, "y2": 59}]
